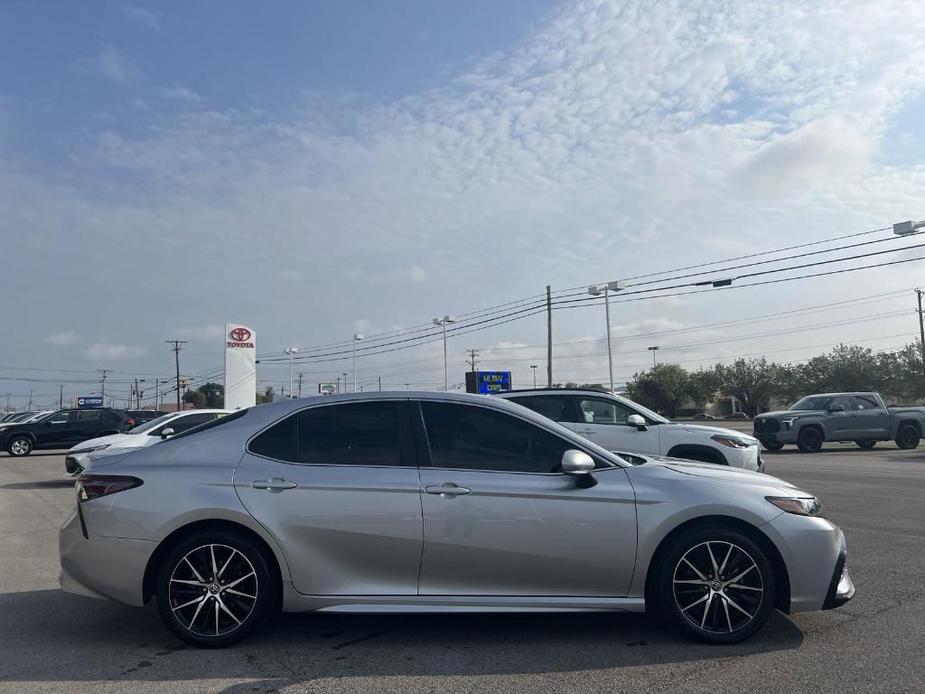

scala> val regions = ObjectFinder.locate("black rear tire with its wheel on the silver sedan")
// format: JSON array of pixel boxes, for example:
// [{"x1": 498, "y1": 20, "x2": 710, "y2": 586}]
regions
[{"x1": 157, "y1": 530, "x2": 280, "y2": 648}]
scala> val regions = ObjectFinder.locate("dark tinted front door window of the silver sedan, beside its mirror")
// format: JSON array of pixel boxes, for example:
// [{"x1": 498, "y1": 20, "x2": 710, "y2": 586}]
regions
[{"x1": 421, "y1": 402, "x2": 575, "y2": 473}]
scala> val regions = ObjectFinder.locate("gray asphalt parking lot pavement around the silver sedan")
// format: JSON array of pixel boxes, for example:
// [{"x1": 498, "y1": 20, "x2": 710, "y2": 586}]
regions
[{"x1": 0, "y1": 448, "x2": 925, "y2": 694}]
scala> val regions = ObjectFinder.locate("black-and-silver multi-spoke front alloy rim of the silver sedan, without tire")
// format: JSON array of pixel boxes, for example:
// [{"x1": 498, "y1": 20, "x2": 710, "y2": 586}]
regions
[{"x1": 672, "y1": 540, "x2": 764, "y2": 634}]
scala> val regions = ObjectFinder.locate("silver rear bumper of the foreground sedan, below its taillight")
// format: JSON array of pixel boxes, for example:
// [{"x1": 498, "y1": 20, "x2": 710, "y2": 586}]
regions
[{"x1": 58, "y1": 509, "x2": 157, "y2": 607}]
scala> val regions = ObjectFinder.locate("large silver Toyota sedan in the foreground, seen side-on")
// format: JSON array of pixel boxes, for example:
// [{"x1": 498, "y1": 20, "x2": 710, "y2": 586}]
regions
[{"x1": 60, "y1": 392, "x2": 854, "y2": 647}]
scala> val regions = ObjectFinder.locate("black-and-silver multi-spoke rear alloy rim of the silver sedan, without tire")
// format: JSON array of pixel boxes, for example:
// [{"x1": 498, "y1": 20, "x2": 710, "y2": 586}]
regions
[{"x1": 168, "y1": 544, "x2": 260, "y2": 637}]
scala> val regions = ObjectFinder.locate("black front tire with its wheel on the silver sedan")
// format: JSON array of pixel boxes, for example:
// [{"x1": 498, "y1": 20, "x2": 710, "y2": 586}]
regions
[{"x1": 656, "y1": 526, "x2": 775, "y2": 644}]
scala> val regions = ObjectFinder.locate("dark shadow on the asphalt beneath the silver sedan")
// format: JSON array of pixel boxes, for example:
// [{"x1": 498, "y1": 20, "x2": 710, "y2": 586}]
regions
[{"x1": 0, "y1": 590, "x2": 803, "y2": 692}]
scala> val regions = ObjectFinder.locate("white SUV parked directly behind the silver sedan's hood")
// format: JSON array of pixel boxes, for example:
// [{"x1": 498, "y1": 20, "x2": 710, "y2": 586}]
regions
[{"x1": 496, "y1": 388, "x2": 764, "y2": 472}]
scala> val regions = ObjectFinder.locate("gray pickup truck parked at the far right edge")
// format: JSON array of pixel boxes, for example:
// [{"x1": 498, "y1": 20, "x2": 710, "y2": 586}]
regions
[{"x1": 754, "y1": 393, "x2": 925, "y2": 453}]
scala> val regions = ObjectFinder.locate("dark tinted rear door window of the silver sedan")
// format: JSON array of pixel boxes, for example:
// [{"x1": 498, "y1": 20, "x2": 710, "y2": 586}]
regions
[{"x1": 296, "y1": 401, "x2": 402, "y2": 465}]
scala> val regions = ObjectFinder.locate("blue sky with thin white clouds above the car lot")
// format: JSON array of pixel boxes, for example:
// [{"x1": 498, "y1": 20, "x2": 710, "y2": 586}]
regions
[{"x1": 0, "y1": 0, "x2": 925, "y2": 406}]
